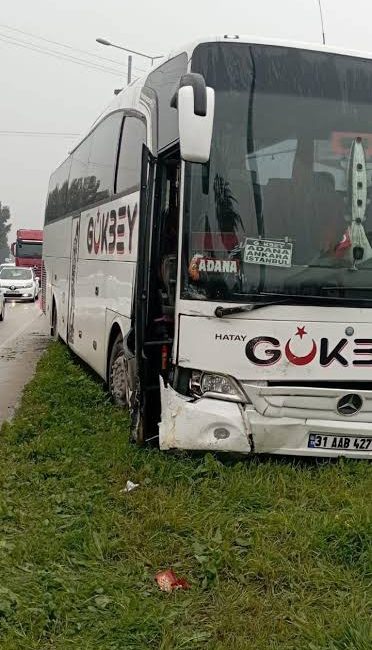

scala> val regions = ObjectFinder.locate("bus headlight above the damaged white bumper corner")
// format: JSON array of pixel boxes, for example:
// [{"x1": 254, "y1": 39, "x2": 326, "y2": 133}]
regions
[{"x1": 190, "y1": 370, "x2": 247, "y2": 402}]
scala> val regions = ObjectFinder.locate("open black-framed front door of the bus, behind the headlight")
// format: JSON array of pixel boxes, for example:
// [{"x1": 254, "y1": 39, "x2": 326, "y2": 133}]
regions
[{"x1": 134, "y1": 147, "x2": 179, "y2": 439}]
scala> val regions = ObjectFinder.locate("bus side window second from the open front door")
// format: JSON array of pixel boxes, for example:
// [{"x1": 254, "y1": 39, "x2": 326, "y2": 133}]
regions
[{"x1": 84, "y1": 112, "x2": 123, "y2": 205}]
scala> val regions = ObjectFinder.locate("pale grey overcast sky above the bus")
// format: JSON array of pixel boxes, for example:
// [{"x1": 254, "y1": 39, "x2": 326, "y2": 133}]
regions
[{"x1": 0, "y1": 0, "x2": 372, "y2": 244}]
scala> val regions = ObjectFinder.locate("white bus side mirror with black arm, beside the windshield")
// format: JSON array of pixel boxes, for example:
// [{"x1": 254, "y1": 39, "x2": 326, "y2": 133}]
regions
[{"x1": 171, "y1": 72, "x2": 214, "y2": 163}]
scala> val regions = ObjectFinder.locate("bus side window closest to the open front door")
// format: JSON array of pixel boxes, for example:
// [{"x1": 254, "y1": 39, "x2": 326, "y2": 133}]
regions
[{"x1": 116, "y1": 117, "x2": 146, "y2": 193}]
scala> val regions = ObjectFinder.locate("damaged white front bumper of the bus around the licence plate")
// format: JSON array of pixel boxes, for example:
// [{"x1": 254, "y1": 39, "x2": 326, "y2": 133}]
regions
[{"x1": 159, "y1": 382, "x2": 372, "y2": 459}]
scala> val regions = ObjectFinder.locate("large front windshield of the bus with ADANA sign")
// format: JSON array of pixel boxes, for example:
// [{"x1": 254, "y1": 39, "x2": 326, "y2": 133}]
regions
[{"x1": 181, "y1": 43, "x2": 372, "y2": 306}]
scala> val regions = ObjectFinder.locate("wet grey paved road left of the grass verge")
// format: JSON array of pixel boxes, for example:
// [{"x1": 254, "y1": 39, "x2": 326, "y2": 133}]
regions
[{"x1": 0, "y1": 302, "x2": 49, "y2": 425}]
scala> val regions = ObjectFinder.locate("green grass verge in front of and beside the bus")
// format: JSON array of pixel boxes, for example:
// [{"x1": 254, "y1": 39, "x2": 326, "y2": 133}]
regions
[{"x1": 0, "y1": 344, "x2": 372, "y2": 650}]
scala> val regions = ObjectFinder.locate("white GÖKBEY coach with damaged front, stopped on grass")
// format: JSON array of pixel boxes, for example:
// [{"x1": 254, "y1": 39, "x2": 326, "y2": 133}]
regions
[{"x1": 43, "y1": 36, "x2": 372, "y2": 458}]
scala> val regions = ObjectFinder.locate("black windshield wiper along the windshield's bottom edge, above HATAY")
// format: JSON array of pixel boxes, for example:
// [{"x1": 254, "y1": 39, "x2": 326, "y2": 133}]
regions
[{"x1": 214, "y1": 294, "x2": 371, "y2": 318}]
